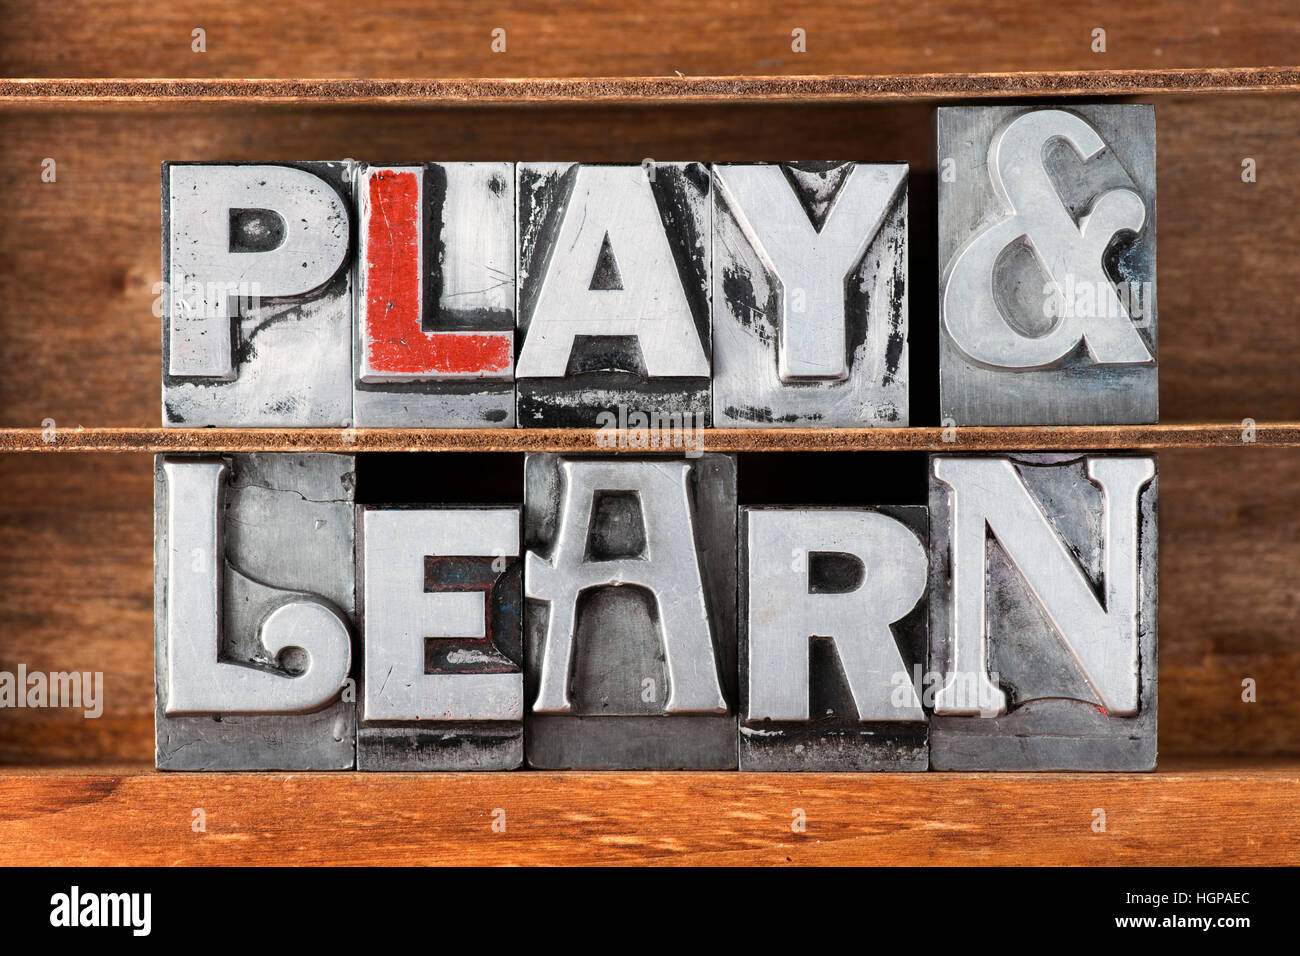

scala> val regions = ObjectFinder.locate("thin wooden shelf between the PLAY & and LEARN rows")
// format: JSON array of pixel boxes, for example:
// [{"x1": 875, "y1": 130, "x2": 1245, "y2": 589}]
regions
[{"x1": 0, "y1": 421, "x2": 1300, "y2": 454}]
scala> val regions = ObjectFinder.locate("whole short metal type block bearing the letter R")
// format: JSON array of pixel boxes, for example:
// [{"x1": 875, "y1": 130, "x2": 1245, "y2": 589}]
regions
[{"x1": 740, "y1": 506, "x2": 930, "y2": 770}]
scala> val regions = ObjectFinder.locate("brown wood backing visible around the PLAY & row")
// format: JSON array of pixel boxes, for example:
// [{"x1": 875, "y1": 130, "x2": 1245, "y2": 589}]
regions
[{"x1": 0, "y1": 94, "x2": 1300, "y2": 428}]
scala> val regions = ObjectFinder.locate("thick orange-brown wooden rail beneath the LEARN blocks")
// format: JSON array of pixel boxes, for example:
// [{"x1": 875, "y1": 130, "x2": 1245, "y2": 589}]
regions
[{"x1": 0, "y1": 761, "x2": 1300, "y2": 866}]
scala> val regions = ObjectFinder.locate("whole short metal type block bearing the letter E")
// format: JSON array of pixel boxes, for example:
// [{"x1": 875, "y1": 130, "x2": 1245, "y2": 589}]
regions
[{"x1": 356, "y1": 507, "x2": 524, "y2": 770}]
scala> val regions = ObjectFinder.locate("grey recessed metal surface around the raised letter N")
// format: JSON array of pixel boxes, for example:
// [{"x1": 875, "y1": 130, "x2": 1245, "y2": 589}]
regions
[{"x1": 930, "y1": 454, "x2": 1160, "y2": 770}]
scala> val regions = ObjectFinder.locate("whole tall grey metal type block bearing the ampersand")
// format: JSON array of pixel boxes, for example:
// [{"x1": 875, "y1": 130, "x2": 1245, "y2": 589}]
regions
[{"x1": 939, "y1": 104, "x2": 1158, "y2": 425}]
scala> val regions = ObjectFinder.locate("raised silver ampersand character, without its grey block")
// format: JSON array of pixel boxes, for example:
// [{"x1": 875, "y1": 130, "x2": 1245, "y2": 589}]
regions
[{"x1": 940, "y1": 109, "x2": 1154, "y2": 369}]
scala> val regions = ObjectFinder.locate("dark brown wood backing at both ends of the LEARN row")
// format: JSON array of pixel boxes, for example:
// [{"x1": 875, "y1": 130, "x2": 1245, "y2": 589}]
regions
[{"x1": 0, "y1": 447, "x2": 1300, "y2": 764}]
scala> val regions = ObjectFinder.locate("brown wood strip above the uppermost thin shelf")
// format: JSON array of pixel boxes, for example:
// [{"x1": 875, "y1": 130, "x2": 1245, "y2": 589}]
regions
[{"x1": 0, "y1": 0, "x2": 1300, "y2": 77}]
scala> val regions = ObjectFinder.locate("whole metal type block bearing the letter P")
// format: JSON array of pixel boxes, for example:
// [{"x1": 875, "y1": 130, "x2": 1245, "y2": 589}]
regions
[{"x1": 163, "y1": 163, "x2": 352, "y2": 427}]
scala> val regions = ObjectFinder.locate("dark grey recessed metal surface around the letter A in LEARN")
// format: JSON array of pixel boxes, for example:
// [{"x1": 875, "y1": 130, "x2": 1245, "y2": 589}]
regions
[{"x1": 524, "y1": 455, "x2": 737, "y2": 770}]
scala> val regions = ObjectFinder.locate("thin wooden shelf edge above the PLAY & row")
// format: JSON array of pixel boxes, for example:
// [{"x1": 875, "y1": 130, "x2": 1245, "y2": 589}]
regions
[{"x1": 0, "y1": 68, "x2": 1300, "y2": 108}]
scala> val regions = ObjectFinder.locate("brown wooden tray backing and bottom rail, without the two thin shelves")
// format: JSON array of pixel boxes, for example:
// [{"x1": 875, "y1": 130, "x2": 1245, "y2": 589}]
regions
[{"x1": 0, "y1": 0, "x2": 1300, "y2": 862}]
